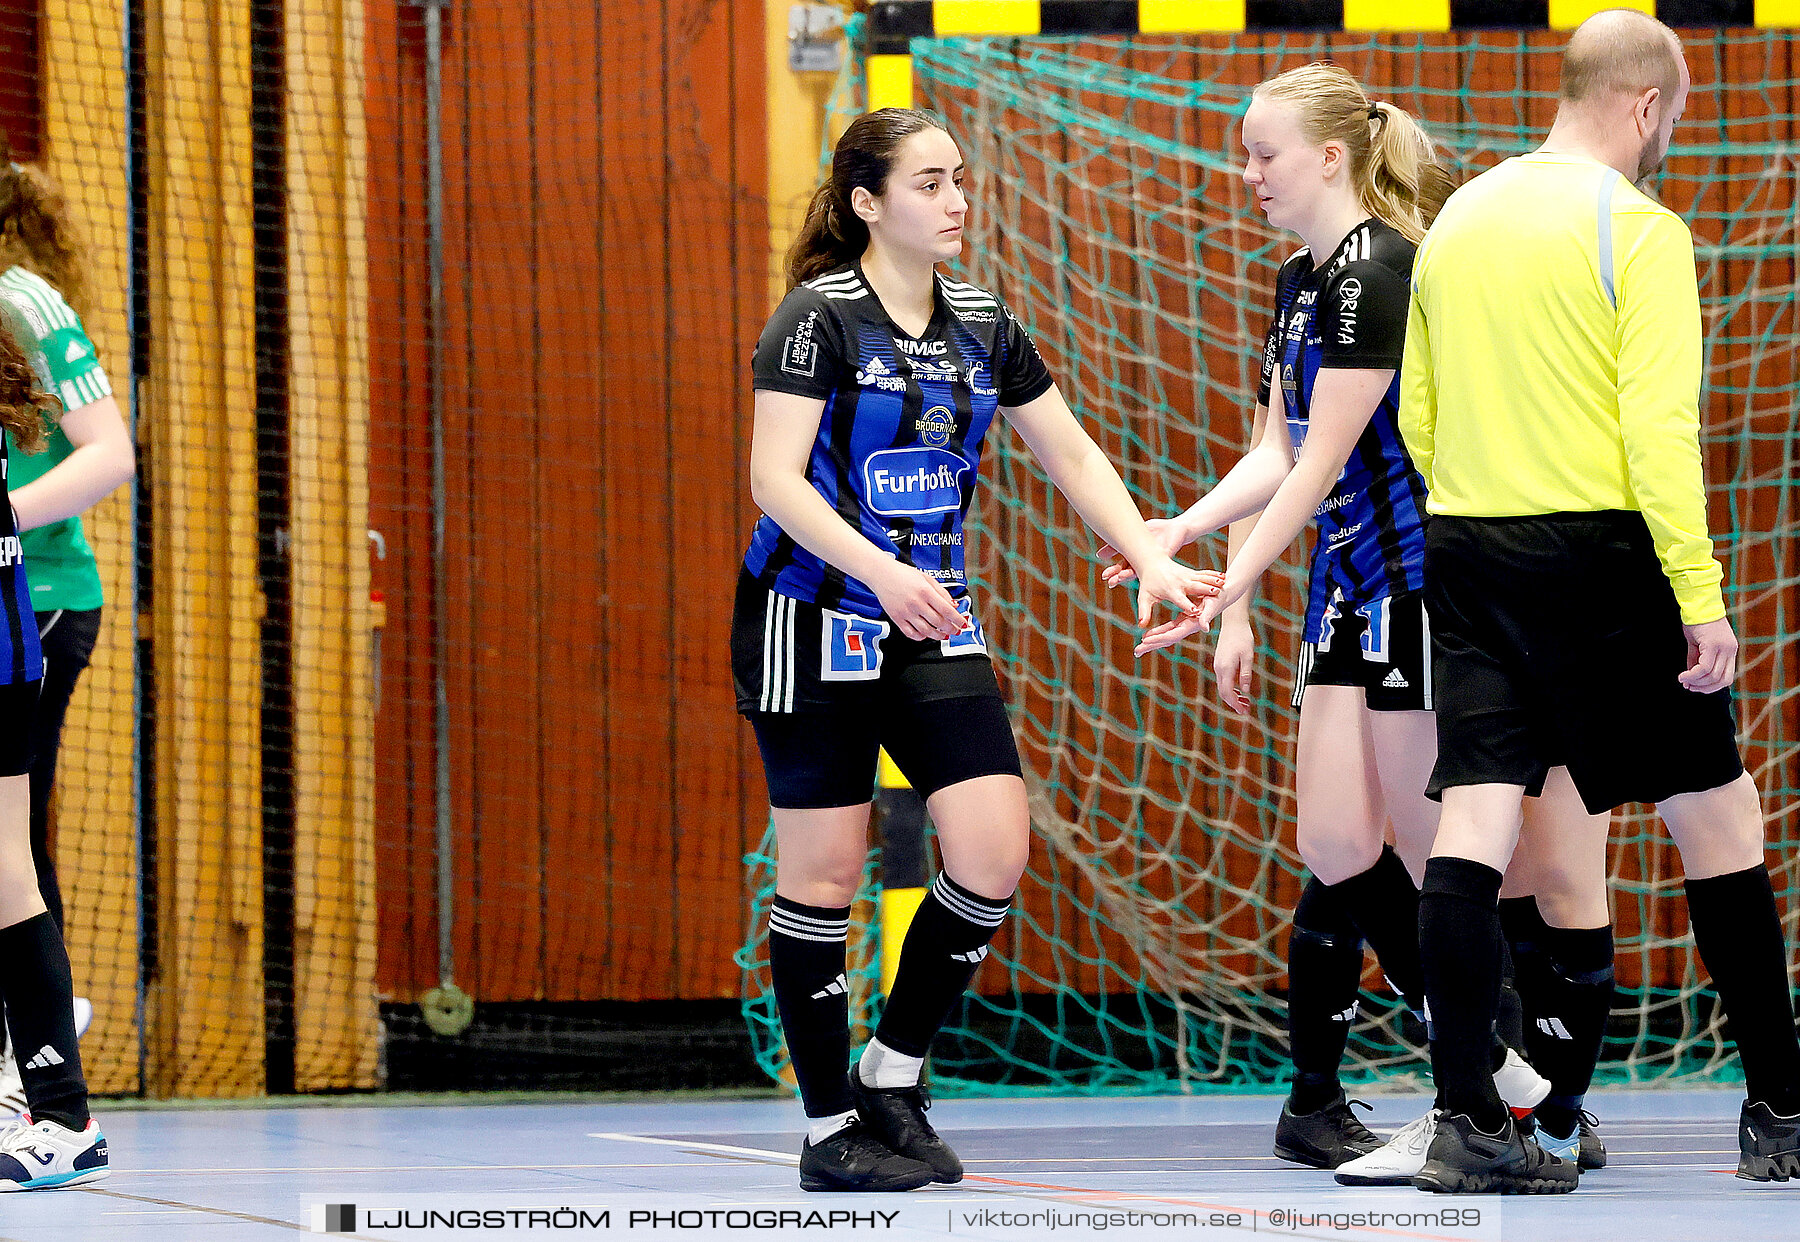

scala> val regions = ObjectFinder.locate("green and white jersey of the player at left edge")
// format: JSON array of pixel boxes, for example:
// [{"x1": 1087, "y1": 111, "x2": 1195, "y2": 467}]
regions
[{"x1": 0, "y1": 266, "x2": 112, "y2": 612}]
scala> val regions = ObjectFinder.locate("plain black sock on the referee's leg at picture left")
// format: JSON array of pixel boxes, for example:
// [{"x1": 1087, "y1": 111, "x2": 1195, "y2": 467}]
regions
[{"x1": 1418, "y1": 859, "x2": 1507, "y2": 1134}]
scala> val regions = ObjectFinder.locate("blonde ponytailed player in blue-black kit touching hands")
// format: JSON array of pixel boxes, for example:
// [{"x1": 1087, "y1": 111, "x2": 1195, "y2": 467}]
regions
[{"x1": 1111, "y1": 65, "x2": 1606, "y2": 1181}]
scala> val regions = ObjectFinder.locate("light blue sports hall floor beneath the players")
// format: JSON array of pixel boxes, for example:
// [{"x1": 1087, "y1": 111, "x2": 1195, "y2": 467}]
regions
[{"x1": 10, "y1": 1091, "x2": 1800, "y2": 1242}]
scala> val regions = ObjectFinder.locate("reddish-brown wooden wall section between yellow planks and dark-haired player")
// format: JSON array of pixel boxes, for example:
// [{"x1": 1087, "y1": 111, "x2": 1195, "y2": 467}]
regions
[{"x1": 365, "y1": 0, "x2": 769, "y2": 1001}]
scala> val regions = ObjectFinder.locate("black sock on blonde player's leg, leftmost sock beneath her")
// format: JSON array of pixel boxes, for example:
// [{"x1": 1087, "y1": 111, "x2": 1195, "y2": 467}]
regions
[{"x1": 1287, "y1": 878, "x2": 1363, "y2": 1112}]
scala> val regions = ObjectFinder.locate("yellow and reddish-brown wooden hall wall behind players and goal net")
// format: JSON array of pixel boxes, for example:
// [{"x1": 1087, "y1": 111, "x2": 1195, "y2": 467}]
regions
[{"x1": 0, "y1": 0, "x2": 1800, "y2": 1096}]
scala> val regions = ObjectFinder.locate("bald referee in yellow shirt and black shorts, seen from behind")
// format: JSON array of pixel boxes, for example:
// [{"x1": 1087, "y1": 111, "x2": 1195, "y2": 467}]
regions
[{"x1": 1400, "y1": 9, "x2": 1800, "y2": 1192}]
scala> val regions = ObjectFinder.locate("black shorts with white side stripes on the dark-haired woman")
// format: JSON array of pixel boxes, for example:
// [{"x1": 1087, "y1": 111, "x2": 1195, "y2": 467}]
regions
[{"x1": 731, "y1": 572, "x2": 1021, "y2": 810}]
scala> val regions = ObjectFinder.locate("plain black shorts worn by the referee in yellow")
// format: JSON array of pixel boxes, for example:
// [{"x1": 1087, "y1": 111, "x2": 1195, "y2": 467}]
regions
[{"x1": 1426, "y1": 511, "x2": 1744, "y2": 812}]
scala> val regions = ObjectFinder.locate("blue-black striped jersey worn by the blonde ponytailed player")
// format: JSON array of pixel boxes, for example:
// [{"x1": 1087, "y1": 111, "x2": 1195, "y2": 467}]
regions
[{"x1": 1260, "y1": 220, "x2": 1426, "y2": 643}]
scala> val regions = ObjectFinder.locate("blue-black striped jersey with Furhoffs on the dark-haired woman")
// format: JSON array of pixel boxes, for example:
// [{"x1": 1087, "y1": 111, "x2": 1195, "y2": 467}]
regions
[{"x1": 743, "y1": 265, "x2": 1053, "y2": 619}]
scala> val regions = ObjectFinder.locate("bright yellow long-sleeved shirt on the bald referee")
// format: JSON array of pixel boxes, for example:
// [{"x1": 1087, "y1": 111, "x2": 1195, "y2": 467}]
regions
[{"x1": 1400, "y1": 153, "x2": 1724, "y2": 625}]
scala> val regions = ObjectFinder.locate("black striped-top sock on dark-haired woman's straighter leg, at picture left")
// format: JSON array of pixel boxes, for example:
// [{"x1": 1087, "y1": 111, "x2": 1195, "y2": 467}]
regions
[{"x1": 769, "y1": 896, "x2": 855, "y2": 1118}]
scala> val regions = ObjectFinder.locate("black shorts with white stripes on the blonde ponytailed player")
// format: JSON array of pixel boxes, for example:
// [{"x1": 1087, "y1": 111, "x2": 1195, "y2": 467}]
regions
[{"x1": 1294, "y1": 590, "x2": 1433, "y2": 711}]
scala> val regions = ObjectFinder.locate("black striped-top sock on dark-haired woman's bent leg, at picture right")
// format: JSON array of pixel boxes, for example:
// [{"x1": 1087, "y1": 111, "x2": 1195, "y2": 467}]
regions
[{"x1": 875, "y1": 871, "x2": 1012, "y2": 1057}]
